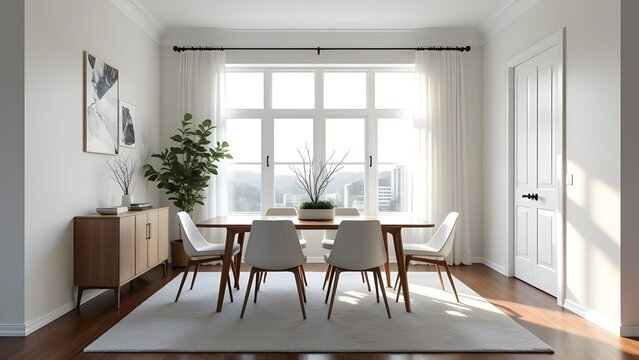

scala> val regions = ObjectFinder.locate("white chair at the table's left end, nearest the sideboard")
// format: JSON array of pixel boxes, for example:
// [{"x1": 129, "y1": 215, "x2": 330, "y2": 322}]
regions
[{"x1": 175, "y1": 211, "x2": 240, "y2": 302}]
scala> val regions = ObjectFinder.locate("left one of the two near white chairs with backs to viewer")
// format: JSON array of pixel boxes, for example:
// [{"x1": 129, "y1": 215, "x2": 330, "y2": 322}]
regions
[{"x1": 240, "y1": 220, "x2": 306, "y2": 319}]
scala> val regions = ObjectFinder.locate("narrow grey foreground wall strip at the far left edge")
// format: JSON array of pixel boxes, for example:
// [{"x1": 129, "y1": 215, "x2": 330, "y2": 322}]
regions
[{"x1": 0, "y1": 0, "x2": 24, "y2": 335}]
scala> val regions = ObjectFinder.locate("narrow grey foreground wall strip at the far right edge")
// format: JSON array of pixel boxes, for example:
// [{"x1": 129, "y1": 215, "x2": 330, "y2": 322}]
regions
[{"x1": 621, "y1": 0, "x2": 639, "y2": 337}]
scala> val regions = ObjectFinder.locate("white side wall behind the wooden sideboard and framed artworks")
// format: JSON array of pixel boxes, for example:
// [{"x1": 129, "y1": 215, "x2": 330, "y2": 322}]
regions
[{"x1": 24, "y1": 0, "x2": 160, "y2": 330}]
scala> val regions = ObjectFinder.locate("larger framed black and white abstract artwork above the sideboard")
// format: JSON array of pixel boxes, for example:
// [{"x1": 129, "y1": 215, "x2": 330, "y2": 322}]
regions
[{"x1": 84, "y1": 52, "x2": 119, "y2": 155}]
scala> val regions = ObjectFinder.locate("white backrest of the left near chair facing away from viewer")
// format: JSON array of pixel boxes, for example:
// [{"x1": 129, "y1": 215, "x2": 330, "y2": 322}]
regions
[{"x1": 244, "y1": 220, "x2": 306, "y2": 270}]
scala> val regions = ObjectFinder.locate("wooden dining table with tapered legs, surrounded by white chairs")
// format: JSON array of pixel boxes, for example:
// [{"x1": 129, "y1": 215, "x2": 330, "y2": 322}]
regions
[{"x1": 196, "y1": 215, "x2": 435, "y2": 312}]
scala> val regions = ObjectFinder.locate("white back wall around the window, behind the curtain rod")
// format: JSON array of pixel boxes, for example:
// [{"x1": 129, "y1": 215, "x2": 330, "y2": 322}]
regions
[{"x1": 161, "y1": 30, "x2": 482, "y2": 260}]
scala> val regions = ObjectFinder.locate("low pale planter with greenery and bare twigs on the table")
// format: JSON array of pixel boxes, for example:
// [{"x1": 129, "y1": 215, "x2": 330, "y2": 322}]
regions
[{"x1": 290, "y1": 147, "x2": 348, "y2": 220}]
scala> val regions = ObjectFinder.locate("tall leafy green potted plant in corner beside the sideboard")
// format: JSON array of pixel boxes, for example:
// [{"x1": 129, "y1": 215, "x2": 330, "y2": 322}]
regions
[{"x1": 144, "y1": 113, "x2": 233, "y2": 266}]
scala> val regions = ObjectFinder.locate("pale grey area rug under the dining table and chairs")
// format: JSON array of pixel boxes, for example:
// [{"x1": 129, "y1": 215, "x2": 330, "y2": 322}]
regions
[{"x1": 85, "y1": 272, "x2": 552, "y2": 353}]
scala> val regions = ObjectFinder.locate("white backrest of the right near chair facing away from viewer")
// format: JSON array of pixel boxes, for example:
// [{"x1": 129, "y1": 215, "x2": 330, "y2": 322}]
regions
[{"x1": 327, "y1": 220, "x2": 386, "y2": 270}]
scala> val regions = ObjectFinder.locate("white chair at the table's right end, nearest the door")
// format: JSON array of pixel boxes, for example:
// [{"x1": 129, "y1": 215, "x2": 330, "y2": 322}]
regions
[{"x1": 394, "y1": 211, "x2": 459, "y2": 302}]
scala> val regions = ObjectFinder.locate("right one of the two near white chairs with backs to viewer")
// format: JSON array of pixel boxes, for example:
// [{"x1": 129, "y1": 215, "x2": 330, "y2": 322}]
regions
[{"x1": 324, "y1": 220, "x2": 391, "y2": 319}]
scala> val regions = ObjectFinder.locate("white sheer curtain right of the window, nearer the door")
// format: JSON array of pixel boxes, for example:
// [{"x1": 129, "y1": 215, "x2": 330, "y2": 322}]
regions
[{"x1": 415, "y1": 51, "x2": 472, "y2": 265}]
